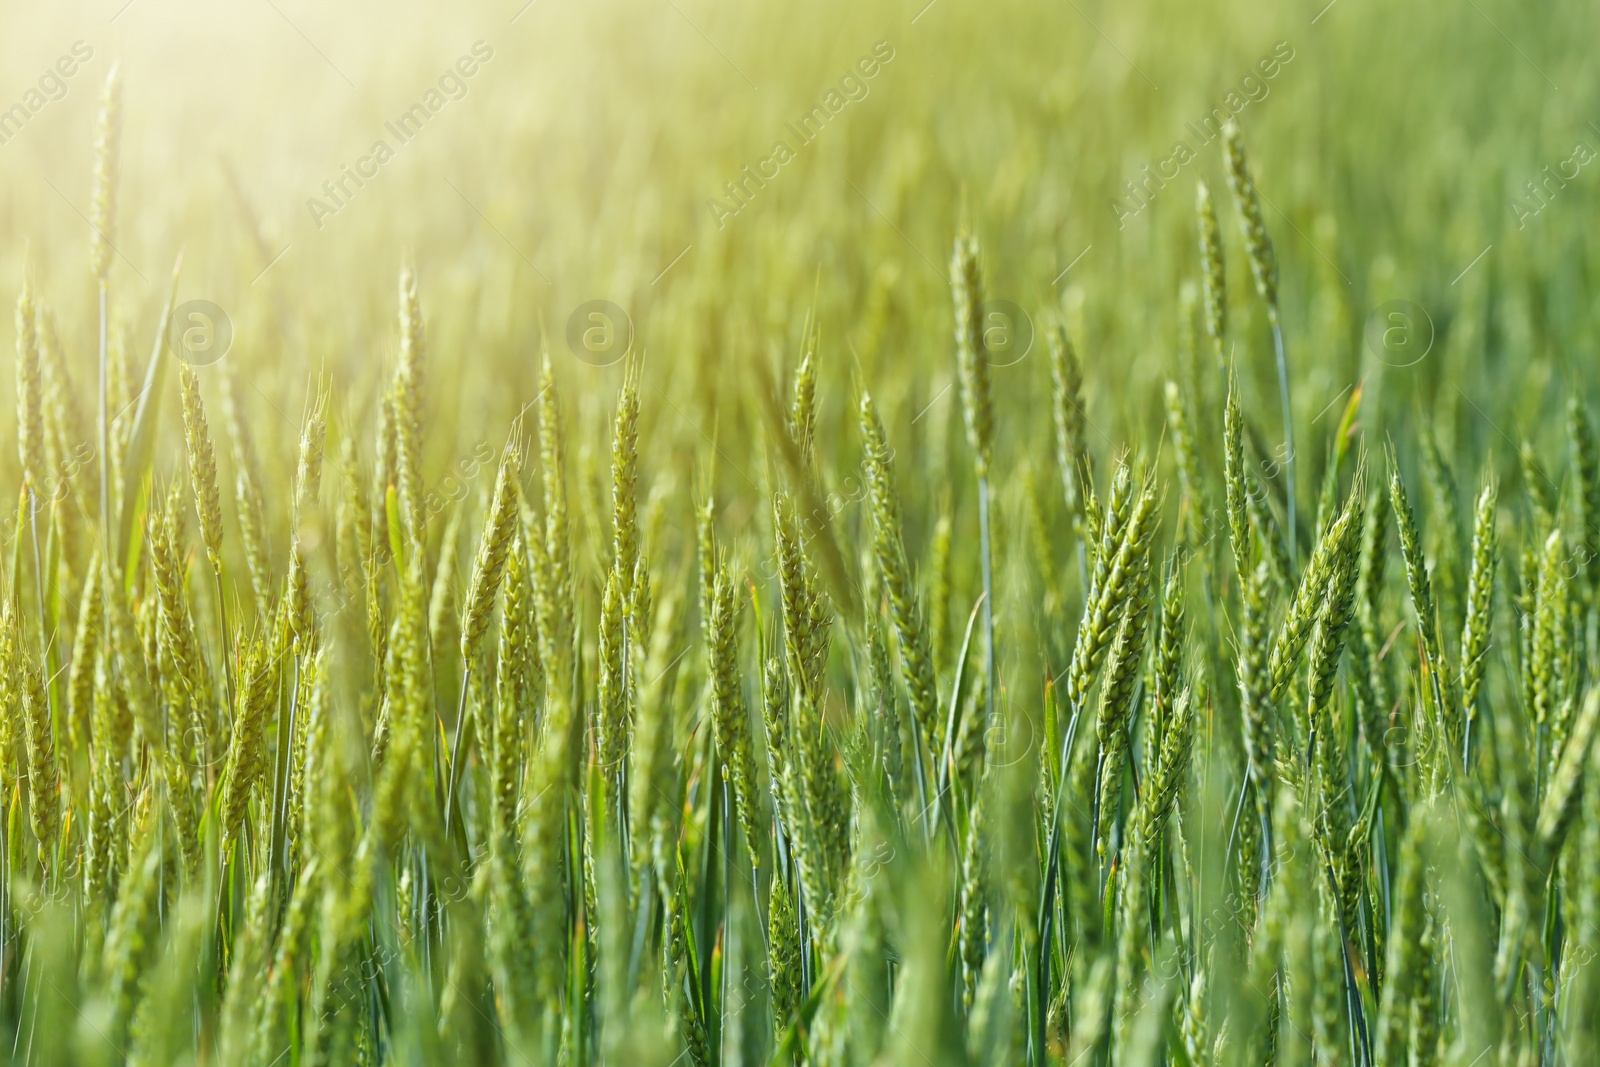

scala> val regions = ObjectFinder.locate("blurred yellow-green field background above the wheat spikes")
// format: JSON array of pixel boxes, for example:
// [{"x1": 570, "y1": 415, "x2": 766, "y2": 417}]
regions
[{"x1": 0, "y1": 0, "x2": 1600, "y2": 534}]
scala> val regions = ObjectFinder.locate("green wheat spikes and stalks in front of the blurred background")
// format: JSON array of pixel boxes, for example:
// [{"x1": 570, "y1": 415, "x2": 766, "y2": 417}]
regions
[{"x1": 0, "y1": 64, "x2": 1600, "y2": 1067}]
